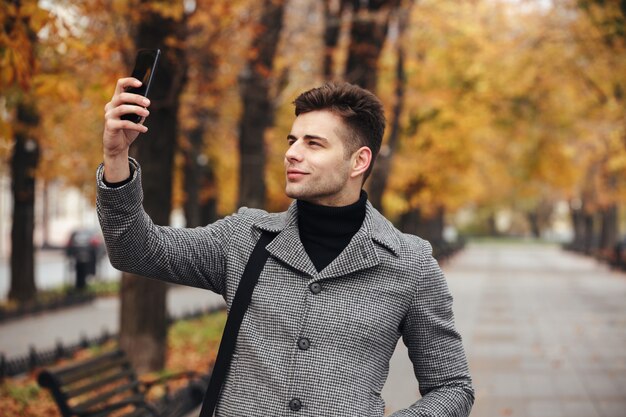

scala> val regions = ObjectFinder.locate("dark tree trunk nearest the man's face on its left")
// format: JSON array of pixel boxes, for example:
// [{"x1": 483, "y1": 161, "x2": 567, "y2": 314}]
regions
[{"x1": 239, "y1": 0, "x2": 285, "y2": 208}]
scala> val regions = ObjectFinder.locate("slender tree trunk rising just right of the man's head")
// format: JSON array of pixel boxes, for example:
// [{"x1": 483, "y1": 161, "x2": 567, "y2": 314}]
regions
[{"x1": 368, "y1": 3, "x2": 412, "y2": 213}]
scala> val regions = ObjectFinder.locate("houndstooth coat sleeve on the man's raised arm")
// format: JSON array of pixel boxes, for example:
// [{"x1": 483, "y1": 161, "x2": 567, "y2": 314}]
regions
[{"x1": 96, "y1": 159, "x2": 246, "y2": 294}]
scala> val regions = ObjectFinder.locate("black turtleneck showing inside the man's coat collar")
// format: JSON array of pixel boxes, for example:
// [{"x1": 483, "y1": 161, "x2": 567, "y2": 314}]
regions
[{"x1": 297, "y1": 191, "x2": 367, "y2": 272}]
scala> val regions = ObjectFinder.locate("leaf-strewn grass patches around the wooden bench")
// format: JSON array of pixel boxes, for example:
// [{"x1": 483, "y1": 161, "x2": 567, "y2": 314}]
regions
[{"x1": 0, "y1": 311, "x2": 226, "y2": 417}]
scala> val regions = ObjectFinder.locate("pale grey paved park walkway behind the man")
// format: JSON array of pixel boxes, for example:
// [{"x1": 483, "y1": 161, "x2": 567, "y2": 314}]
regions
[{"x1": 0, "y1": 244, "x2": 626, "y2": 417}]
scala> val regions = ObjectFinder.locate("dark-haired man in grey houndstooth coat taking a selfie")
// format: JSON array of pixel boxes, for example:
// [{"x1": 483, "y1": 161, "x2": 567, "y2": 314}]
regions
[{"x1": 98, "y1": 78, "x2": 474, "y2": 417}]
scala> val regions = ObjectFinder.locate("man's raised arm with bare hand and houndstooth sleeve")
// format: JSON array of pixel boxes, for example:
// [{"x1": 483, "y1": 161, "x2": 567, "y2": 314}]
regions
[{"x1": 97, "y1": 78, "x2": 240, "y2": 294}]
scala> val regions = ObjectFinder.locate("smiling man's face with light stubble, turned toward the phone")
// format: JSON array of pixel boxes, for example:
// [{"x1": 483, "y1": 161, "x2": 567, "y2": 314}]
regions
[{"x1": 285, "y1": 110, "x2": 358, "y2": 206}]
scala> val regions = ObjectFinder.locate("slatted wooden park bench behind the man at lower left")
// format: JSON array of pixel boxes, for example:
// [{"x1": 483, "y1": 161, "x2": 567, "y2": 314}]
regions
[{"x1": 37, "y1": 350, "x2": 208, "y2": 417}]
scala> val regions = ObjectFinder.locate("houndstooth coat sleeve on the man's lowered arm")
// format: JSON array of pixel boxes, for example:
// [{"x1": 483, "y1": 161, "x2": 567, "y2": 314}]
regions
[{"x1": 392, "y1": 241, "x2": 474, "y2": 417}]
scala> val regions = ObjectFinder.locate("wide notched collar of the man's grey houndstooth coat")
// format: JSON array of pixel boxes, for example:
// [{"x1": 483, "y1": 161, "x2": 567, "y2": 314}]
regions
[{"x1": 254, "y1": 201, "x2": 400, "y2": 278}]
